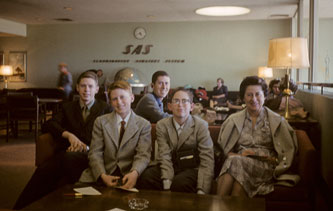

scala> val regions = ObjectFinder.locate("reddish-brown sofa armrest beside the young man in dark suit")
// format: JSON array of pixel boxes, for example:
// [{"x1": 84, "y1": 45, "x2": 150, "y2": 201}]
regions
[{"x1": 35, "y1": 133, "x2": 56, "y2": 167}]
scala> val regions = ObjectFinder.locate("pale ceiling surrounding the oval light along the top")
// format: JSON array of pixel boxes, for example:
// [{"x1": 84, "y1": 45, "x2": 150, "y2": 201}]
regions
[{"x1": 0, "y1": 0, "x2": 333, "y2": 24}]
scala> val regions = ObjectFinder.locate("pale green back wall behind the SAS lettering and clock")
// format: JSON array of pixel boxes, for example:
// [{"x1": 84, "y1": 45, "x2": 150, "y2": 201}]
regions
[{"x1": 0, "y1": 20, "x2": 291, "y2": 90}]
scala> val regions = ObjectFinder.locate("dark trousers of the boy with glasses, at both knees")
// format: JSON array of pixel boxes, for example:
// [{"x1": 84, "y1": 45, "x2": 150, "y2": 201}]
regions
[{"x1": 136, "y1": 165, "x2": 198, "y2": 193}]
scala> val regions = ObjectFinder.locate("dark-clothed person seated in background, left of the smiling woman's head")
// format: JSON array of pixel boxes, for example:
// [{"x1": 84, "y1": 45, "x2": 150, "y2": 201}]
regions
[{"x1": 210, "y1": 78, "x2": 228, "y2": 108}]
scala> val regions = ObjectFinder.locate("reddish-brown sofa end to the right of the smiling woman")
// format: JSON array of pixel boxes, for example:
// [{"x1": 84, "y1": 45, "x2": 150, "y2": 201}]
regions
[{"x1": 296, "y1": 130, "x2": 318, "y2": 185}]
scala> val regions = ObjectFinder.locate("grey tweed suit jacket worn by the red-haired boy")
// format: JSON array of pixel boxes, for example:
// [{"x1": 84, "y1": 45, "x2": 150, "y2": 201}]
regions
[{"x1": 80, "y1": 111, "x2": 151, "y2": 182}]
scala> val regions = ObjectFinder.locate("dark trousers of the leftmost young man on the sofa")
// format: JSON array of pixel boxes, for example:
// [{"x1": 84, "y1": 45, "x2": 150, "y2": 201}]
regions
[{"x1": 13, "y1": 151, "x2": 88, "y2": 209}]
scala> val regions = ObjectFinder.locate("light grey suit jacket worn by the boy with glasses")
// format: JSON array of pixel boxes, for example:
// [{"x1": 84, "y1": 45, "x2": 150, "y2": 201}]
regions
[{"x1": 156, "y1": 115, "x2": 214, "y2": 193}]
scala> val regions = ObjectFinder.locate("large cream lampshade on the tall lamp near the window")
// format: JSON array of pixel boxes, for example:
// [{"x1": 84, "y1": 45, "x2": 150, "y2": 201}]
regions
[{"x1": 267, "y1": 37, "x2": 310, "y2": 68}]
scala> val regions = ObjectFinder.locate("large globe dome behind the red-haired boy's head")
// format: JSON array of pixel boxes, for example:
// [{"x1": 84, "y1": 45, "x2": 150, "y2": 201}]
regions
[{"x1": 114, "y1": 68, "x2": 148, "y2": 87}]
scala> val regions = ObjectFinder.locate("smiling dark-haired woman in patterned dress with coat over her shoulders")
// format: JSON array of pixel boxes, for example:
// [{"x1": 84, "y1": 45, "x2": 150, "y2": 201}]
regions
[{"x1": 217, "y1": 76, "x2": 299, "y2": 197}]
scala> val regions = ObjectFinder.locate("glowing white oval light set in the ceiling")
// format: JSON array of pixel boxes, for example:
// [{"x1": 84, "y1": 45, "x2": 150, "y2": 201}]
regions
[{"x1": 195, "y1": 6, "x2": 250, "y2": 16}]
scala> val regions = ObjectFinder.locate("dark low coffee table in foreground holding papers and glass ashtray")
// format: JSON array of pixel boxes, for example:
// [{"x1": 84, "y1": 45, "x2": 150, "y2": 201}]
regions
[{"x1": 25, "y1": 185, "x2": 265, "y2": 211}]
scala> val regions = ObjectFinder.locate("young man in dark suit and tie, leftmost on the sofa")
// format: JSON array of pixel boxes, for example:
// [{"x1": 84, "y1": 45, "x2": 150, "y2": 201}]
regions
[{"x1": 14, "y1": 72, "x2": 112, "y2": 209}]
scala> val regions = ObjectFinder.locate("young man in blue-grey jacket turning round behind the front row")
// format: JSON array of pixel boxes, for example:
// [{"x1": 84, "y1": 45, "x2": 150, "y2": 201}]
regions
[{"x1": 135, "y1": 70, "x2": 170, "y2": 123}]
